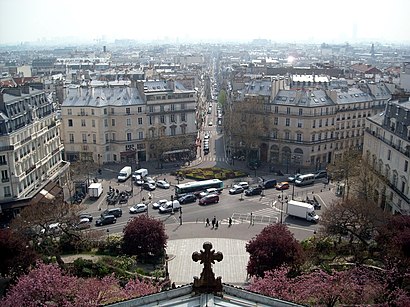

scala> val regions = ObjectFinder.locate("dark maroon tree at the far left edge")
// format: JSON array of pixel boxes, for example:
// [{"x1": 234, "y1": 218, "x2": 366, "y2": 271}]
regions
[{"x1": 0, "y1": 229, "x2": 38, "y2": 277}]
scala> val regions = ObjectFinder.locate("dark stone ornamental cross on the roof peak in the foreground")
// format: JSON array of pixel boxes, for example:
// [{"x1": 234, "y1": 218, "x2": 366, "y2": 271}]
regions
[{"x1": 192, "y1": 242, "x2": 223, "y2": 294}]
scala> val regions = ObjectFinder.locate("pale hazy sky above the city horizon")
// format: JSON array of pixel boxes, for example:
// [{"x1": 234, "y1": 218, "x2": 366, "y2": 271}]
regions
[{"x1": 0, "y1": 0, "x2": 410, "y2": 44}]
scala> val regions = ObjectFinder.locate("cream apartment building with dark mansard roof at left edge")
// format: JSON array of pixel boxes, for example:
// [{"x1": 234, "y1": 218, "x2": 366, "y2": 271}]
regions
[{"x1": 0, "y1": 85, "x2": 68, "y2": 213}]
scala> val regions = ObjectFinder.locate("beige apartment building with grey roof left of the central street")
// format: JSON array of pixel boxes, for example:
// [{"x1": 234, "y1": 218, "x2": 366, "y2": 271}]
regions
[{"x1": 61, "y1": 80, "x2": 197, "y2": 165}]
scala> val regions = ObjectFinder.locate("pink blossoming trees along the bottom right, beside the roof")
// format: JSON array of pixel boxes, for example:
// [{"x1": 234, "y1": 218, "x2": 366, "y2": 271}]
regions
[{"x1": 249, "y1": 267, "x2": 410, "y2": 306}]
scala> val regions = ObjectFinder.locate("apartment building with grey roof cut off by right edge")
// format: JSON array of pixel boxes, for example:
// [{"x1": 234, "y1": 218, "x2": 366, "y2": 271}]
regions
[{"x1": 363, "y1": 101, "x2": 410, "y2": 214}]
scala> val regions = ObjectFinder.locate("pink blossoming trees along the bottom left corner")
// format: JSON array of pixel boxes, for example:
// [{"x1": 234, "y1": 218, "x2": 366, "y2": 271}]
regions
[{"x1": 0, "y1": 263, "x2": 159, "y2": 307}]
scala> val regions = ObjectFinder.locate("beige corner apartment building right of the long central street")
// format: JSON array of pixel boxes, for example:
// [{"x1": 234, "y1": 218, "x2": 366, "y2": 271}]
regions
[{"x1": 235, "y1": 75, "x2": 391, "y2": 172}]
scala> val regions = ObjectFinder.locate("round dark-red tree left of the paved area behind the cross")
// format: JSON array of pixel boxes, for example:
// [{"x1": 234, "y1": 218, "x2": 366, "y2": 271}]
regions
[{"x1": 122, "y1": 214, "x2": 168, "y2": 257}]
